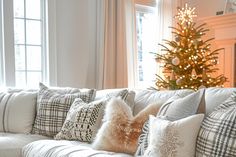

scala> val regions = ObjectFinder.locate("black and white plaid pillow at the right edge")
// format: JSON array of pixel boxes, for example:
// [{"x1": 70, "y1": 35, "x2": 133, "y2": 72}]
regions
[{"x1": 196, "y1": 92, "x2": 236, "y2": 157}]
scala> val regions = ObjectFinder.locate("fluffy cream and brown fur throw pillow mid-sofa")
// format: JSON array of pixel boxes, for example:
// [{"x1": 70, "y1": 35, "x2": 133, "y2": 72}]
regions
[{"x1": 93, "y1": 98, "x2": 160, "y2": 154}]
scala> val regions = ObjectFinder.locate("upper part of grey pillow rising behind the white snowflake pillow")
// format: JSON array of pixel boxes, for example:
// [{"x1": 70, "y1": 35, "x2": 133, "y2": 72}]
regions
[{"x1": 158, "y1": 89, "x2": 205, "y2": 121}]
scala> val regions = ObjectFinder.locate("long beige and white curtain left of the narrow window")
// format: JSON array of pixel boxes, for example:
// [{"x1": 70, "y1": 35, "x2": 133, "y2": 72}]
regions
[{"x1": 96, "y1": 0, "x2": 136, "y2": 89}]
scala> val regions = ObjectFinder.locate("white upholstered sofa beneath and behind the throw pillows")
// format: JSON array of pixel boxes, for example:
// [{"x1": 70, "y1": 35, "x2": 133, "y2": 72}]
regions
[{"x1": 0, "y1": 88, "x2": 236, "y2": 157}]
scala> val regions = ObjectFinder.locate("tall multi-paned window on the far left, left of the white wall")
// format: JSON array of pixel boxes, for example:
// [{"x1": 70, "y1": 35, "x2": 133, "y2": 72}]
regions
[{"x1": 0, "y1": 0, "x2": 48, "y2": 87}]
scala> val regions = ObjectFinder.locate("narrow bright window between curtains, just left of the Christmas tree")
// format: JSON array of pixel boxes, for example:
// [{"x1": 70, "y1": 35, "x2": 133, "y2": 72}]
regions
[{"x1": 136, "y1": 5, "x2": 158, "y2": 87}]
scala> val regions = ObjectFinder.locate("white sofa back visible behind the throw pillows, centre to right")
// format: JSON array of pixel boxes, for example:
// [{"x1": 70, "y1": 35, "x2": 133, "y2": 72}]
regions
[{"x1": 95, "y1": 87, "x2": 236, "y2": 115}]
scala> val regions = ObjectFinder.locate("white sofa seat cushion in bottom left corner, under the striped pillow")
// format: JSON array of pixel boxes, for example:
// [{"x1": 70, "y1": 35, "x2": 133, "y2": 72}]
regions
[{"x1": 0, "y1": 132, "x2": 48, "y2": 157}]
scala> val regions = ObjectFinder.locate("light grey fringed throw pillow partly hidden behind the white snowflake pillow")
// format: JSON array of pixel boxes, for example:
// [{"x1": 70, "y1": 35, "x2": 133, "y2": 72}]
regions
[{"x1": 135, "y1": 89, "x2": 205, "y2": 156}]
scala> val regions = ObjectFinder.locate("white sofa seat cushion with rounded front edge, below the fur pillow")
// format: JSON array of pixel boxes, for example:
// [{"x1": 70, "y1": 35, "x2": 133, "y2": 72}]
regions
[{"x1": 22, "y1": 140, "x2": 131, "y2": 157}]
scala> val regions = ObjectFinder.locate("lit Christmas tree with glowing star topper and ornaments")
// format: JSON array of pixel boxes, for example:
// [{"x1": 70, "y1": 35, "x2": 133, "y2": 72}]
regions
[{"x1": 156, "y1": 4, "x2": 227, "y2": 90}]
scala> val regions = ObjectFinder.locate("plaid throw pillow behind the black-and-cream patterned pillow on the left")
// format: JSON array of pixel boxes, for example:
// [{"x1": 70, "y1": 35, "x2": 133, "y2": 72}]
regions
[{"x1": 32, "y1": 84, "x2": 95, "y2": 136}]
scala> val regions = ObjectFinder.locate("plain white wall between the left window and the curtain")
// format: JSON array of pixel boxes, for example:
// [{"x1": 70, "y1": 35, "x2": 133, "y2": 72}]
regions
[{"x1": 48, "y1": 0, "x2": 96, "y2": 88}]
